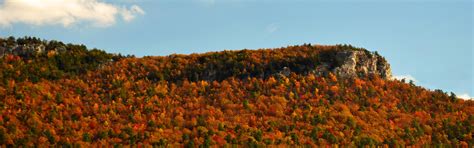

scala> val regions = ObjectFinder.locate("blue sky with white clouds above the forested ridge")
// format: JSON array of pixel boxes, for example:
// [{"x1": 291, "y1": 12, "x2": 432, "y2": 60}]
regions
[{"x1": 0, "y1": 0, "x2": 474, "y2": 98}]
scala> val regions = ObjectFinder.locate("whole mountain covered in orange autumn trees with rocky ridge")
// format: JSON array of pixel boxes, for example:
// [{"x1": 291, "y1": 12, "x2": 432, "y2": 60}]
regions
[{"x1": 0, "y1": 37, "x2": 474, "y2": 147}]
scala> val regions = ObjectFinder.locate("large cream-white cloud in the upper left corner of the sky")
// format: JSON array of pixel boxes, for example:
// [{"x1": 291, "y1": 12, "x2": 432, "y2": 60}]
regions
[{"x1": 0, "y1": 0, "x2": 145, "y2": 27}]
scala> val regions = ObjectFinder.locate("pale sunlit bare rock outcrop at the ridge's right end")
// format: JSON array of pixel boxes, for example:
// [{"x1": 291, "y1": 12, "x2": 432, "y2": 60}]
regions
[{"x1": 332, "y1": 50, "x2": 392, "y2": 79}]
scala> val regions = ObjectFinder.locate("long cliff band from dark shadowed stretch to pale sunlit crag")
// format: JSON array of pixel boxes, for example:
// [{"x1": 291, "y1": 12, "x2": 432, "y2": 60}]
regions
[{"x1": 171, "y1": 49, "x2": 392, "y2": 81}]
